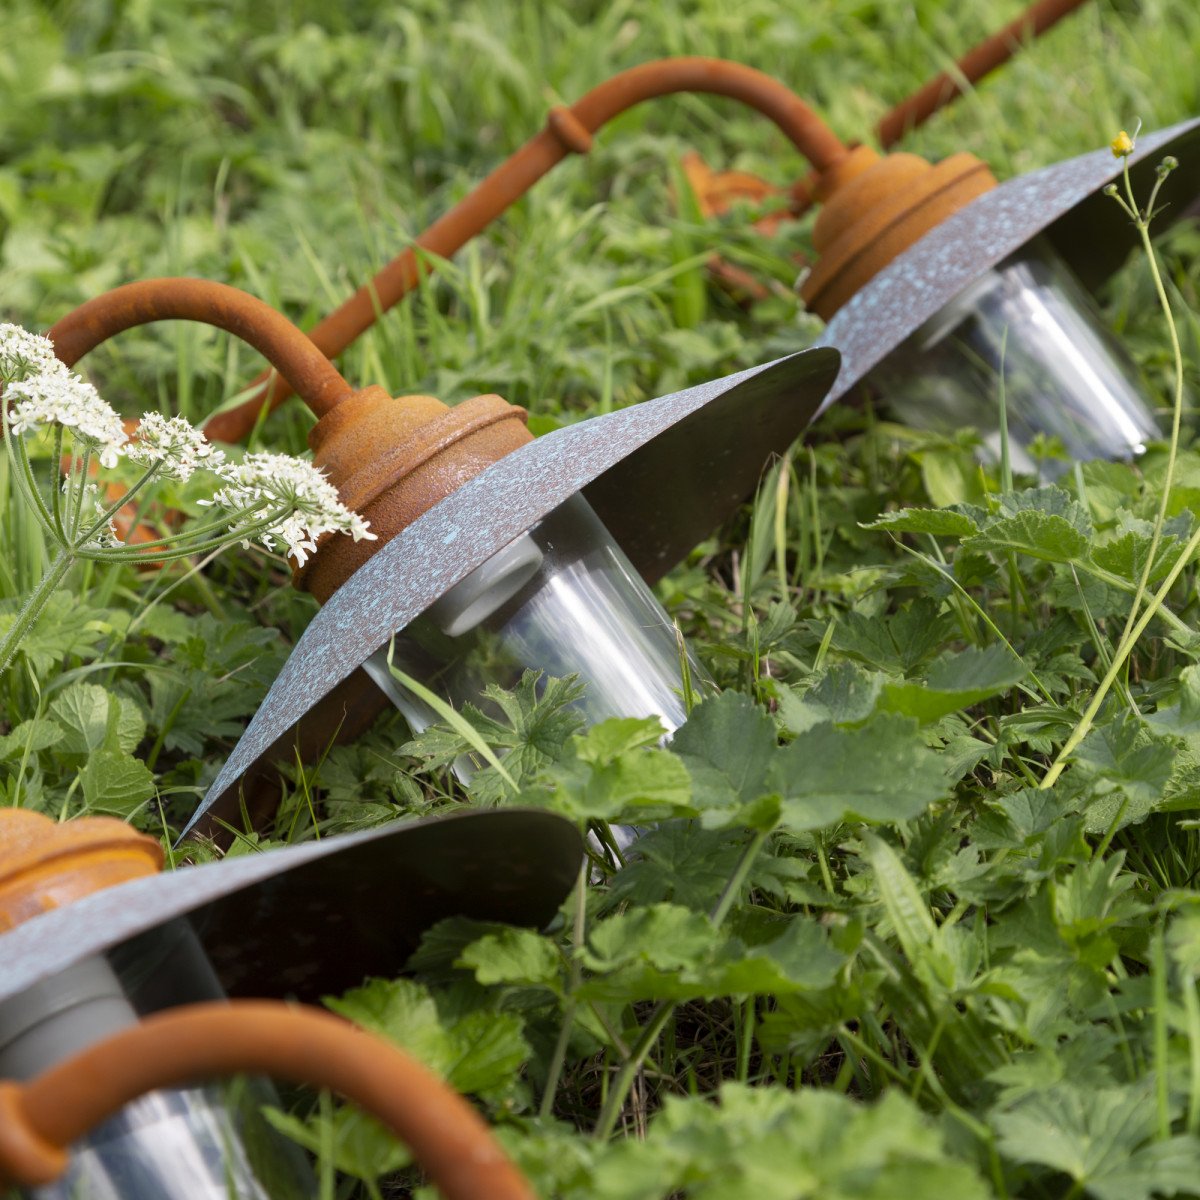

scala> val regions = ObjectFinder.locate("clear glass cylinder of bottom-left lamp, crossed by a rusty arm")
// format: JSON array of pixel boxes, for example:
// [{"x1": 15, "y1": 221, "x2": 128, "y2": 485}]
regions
[{"x1": 0, "y1": 920, "x2": 317, "y2": 1200}]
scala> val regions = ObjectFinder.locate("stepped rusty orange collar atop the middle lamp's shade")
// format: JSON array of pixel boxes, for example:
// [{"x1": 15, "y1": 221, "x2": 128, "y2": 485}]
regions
[{"x1": 295, "y1": 388, "x2": 533, "y2": 604}]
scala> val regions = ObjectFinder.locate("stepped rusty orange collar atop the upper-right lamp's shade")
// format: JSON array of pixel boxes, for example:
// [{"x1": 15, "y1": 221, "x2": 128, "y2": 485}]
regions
[{"x1": 800, "y1": 146, "x2": 996, "y2": 320}]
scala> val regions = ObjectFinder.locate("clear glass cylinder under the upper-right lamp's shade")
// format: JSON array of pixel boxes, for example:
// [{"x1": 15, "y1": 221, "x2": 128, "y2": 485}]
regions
[{"x1": 870, "y1": 239, "x2": 1160, "y2": 476}]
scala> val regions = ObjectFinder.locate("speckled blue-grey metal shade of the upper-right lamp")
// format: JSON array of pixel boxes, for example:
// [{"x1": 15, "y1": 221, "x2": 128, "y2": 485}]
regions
[{"x1": 821, "y1": 119, "x2": 1200, "y2": 407}]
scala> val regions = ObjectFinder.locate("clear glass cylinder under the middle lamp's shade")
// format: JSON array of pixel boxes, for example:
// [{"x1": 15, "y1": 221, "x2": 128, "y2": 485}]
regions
[{"x1": 364, "y1": 496, "x2": 704, "y2": 748}]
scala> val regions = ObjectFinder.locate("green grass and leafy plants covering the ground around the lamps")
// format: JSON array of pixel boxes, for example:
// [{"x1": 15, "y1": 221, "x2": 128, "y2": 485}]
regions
[{"x1": 7, "y1": 0, "x2": 1200, "y2": 1200}]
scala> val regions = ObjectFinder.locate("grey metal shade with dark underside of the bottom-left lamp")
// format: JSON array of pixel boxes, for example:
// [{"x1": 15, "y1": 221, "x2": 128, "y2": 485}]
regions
[{"x1": 0, "y1": 809, "x2": 583, "y2": 1008}]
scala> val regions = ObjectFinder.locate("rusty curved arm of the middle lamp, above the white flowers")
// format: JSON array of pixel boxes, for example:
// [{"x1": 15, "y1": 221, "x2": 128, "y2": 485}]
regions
[{"x1": 48, "y1": 277, "x2": 353, "y2": 416}]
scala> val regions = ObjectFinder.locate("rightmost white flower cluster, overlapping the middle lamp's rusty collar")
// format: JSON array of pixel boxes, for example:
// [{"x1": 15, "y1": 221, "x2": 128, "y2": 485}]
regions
[{"x1": 199, "y1": 454, "x2": 376, "y2": 566}]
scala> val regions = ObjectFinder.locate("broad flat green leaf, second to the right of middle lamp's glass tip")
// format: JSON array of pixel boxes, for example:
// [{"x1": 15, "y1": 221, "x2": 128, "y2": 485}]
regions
[{"x1": 772, "y1": 713, "x2": 947, "y2": 830}]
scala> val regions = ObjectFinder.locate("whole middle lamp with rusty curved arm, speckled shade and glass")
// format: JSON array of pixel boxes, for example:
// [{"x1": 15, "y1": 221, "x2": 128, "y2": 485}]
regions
[{"x1": 42, "y1": 280, "x2": 839, "y2": 832}]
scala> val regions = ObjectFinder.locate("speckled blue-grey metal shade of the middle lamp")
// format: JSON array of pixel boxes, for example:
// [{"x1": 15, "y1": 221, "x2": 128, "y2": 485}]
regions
[{"x1": 187, "y1": 350, "x2": 839, "y2": 833}]
